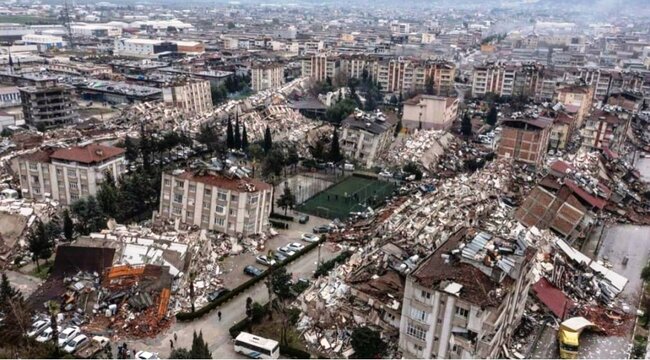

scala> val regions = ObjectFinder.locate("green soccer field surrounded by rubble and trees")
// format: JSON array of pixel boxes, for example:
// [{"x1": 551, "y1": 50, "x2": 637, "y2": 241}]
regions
[{"x1": 298, "y1": 176, "x2": 394, "y2": 220}]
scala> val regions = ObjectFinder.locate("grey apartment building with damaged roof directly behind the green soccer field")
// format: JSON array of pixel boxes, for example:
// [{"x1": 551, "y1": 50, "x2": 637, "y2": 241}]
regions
[{"x1": 340, "y1": 111, "x2": 396, "y2": 168}]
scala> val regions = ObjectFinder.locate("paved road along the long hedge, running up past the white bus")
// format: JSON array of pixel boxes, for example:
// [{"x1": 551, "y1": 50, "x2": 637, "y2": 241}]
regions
[{"x1": 127, "y1": 233, "x2": 337, "y2": 359}]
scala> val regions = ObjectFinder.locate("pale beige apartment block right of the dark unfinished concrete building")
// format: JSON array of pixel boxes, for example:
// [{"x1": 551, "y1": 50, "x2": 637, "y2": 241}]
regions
[{"x1": 162, "y1": 79, "x2": 213, "y2": 114}]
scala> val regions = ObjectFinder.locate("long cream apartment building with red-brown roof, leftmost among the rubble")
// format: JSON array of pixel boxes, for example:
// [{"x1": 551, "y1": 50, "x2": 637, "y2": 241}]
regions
[{"x1": 12, "y1": 144, "x2": 126, "y2": 205}]
